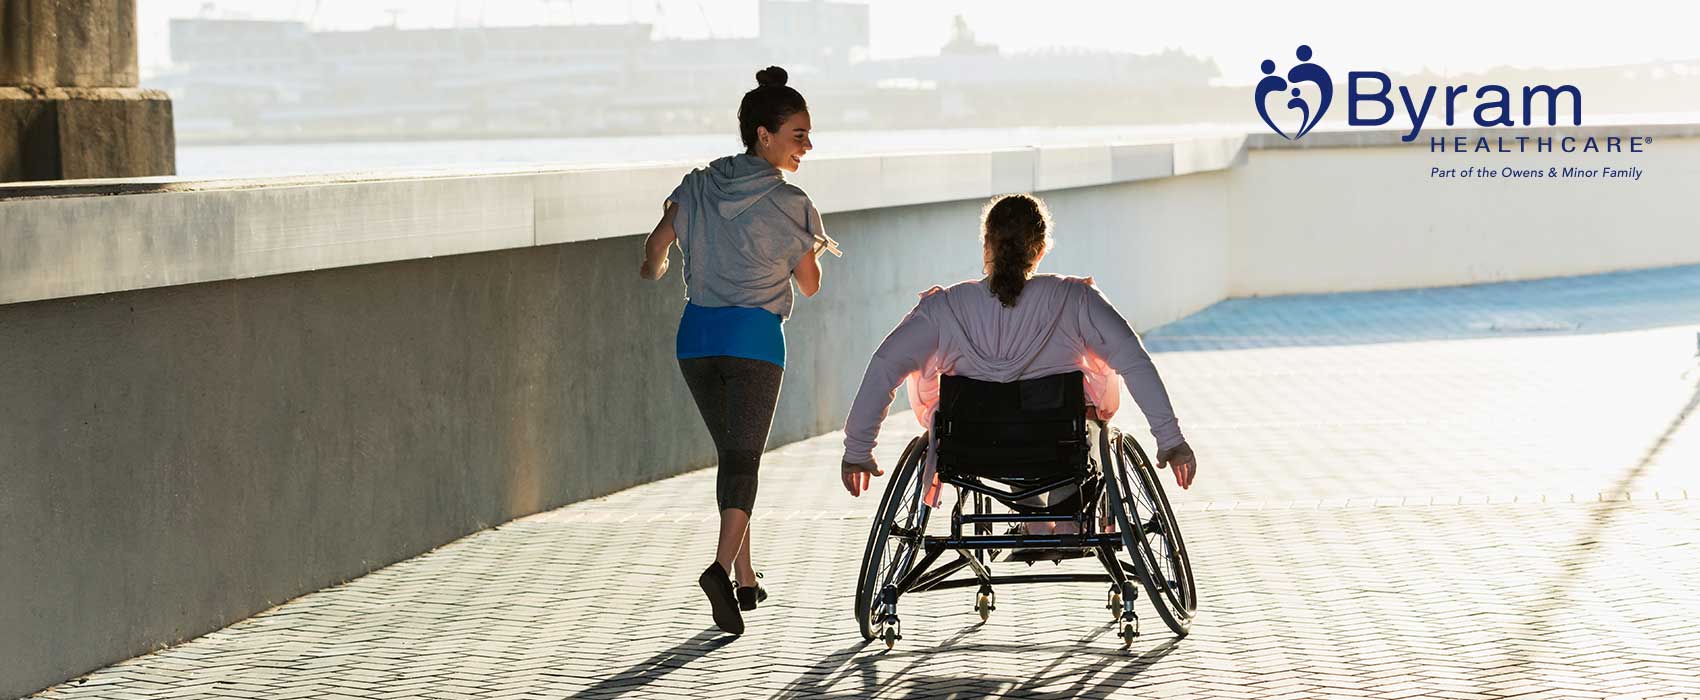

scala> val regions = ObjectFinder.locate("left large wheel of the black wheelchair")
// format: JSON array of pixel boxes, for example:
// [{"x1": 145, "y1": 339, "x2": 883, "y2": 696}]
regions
[{"x1": 855, "y1": 433, "x2": 932, "y2": 647}]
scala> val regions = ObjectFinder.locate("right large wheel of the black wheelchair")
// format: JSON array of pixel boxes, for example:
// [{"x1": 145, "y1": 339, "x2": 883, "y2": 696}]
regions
[{"x1": 1105, "y1": 432, "x2": 1199, "y2": 637}]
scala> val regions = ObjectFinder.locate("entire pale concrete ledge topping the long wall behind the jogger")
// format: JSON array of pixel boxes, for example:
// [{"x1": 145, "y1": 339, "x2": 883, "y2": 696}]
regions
[{"x1": 0, "y1": 139, "x2": 1241, "y2": 304}]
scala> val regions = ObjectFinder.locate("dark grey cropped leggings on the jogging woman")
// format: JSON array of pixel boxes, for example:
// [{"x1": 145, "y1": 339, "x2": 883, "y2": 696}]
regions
[{"x1": 678, "y1": 355, "x2": 785, "y2": 513}]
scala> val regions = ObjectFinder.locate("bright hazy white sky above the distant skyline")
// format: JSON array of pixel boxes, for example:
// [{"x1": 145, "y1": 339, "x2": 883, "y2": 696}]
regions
[{"x1": 139, "y1": 0, "x2": 1700, "y2": 83}]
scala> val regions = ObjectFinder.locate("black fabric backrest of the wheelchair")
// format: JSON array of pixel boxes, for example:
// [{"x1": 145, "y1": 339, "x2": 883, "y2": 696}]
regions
[{"x1": 933, "y1": 372, "x2": 1090, "y2": 477}]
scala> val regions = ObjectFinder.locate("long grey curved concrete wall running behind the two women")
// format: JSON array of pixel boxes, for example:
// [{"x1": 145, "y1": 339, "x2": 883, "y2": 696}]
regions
[{"x1": 0, "y1": 161, "x2": 1227, "y2": 697}]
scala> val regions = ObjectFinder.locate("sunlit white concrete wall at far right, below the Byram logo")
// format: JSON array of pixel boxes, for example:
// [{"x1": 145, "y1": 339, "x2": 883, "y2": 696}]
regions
[{"x1": 1229, "y1": 129, "x2": 1700, "y2": 296}]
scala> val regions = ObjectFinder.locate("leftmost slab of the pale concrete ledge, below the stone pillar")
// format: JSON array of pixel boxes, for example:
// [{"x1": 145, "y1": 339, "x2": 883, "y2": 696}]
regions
[{"x1": 0, "y1": 178, "x2": 536, "y2": 302}]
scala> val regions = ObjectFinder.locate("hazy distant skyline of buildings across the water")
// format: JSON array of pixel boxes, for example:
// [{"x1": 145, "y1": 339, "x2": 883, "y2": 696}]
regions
[{"x1": 150, "y1": 0, "x2": 1216, "y2": 143}]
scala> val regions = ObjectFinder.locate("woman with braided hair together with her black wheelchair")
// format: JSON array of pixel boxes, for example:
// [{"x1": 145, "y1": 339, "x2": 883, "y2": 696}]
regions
[{"x1": 842, "y1": 195, "x2": 1197, "y2": 644}]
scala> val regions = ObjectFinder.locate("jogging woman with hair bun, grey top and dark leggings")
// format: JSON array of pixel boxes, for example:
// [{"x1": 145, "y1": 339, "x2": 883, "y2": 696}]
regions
[{"x1": 639, "y1": 66, "x2": 835, "y2": 634}]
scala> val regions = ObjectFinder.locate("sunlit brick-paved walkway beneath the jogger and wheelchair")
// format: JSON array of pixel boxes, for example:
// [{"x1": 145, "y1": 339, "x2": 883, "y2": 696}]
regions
[{"x1": 29, "y1": 267, "x2": 1700, "y2": 700}]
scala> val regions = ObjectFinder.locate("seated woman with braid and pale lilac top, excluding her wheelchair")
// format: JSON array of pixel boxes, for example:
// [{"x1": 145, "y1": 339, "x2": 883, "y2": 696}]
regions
[{"x1": 842, "y1": 194, "x2": 1197, "y2": 496}]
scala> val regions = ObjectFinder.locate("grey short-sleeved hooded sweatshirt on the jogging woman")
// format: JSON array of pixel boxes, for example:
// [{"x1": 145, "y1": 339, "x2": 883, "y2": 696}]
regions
[{"x1": 666, "y1": 153, "x2": 826, "y2": 318}]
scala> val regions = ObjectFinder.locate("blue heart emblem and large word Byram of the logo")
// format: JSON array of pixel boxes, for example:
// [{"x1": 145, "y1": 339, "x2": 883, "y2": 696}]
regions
[{"x1": 1253, "y1": 46, "x2": 1583, "y2": 141}]
